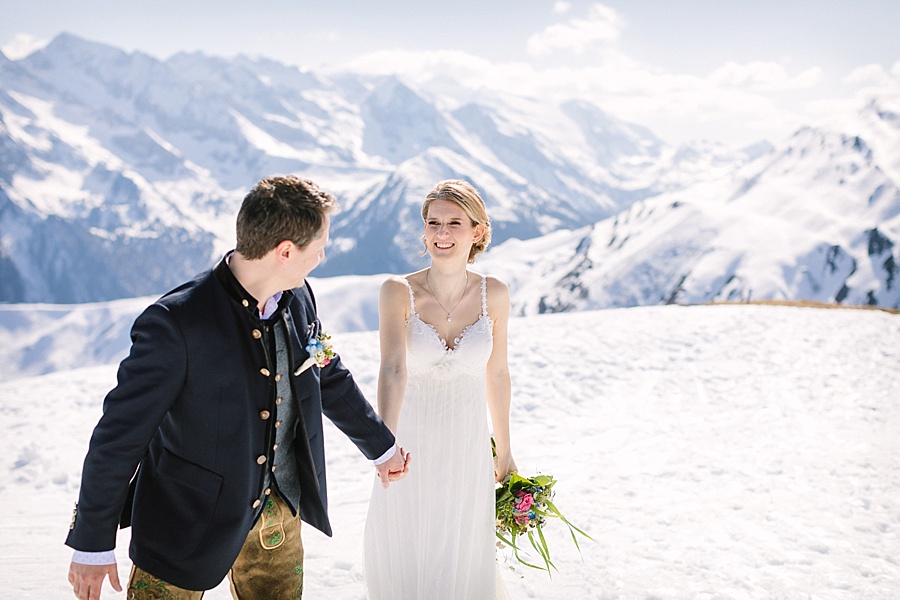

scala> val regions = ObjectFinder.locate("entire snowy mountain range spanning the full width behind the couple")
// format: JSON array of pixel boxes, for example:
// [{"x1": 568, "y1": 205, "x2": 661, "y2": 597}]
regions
[{"x1": 0, "y1": 34, "x2": 900, "y2": 314}]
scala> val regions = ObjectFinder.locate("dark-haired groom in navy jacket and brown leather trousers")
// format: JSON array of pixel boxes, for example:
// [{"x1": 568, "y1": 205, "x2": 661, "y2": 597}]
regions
[{"x1": 66, "y1": 177, "x2": 408, "y2": 600}]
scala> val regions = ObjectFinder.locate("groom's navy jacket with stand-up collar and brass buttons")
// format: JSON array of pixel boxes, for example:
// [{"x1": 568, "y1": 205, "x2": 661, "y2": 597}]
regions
[{"x1": 66, "y1": 255, "x2": 394, "y2": 590}]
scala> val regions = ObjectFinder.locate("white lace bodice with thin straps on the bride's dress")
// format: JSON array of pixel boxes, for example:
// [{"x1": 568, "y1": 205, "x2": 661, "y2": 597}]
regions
[{"x1": 406, "y1": 275, "x2": 493, "y2": 380}]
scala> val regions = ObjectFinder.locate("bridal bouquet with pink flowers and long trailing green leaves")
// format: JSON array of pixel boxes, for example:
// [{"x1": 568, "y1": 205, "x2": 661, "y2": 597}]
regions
[{"x1": 496, "y1": 446, "x2": 593, "y2": 574}]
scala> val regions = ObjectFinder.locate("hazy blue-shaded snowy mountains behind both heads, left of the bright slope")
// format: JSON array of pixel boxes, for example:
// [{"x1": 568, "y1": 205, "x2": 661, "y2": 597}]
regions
[{"x1": 0, "y1": 34, "x2": 751, "y2": 302}]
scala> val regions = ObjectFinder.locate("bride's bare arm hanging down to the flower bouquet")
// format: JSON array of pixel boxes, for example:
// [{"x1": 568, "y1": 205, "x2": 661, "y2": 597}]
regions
[{"x1": 487, "y1": 277, "x2": 517, "y2": 481}]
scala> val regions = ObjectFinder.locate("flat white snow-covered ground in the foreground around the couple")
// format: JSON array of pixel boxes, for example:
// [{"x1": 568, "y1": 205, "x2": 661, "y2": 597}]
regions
[{"x1": 0, "y1": 305, "x2": 900, "y2": 600}]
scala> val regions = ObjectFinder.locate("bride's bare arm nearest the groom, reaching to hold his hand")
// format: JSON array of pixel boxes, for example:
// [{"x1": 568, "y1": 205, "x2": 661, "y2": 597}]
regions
[{"x1": 378, "y1": 277, "x2": 409, "y2": 435}]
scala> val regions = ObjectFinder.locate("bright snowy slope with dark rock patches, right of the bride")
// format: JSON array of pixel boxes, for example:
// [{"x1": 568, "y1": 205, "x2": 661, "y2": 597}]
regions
[{"x1": 482, "y1": 99, "x2": 900, "y2": 314}]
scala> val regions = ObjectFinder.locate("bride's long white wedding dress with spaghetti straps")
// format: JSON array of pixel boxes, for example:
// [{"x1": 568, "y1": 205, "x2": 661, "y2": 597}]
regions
[{"x1": 364, "y1": 276, "x2": 507, "y2": 600}]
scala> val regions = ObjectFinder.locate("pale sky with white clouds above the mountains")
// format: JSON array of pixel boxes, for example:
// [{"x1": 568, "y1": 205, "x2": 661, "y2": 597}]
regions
[{"x1": 0, "y1": 0, "x2": 900, "y2": 143}]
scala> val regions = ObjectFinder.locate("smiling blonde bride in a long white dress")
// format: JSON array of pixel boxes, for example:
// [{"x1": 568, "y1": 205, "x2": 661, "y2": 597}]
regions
[{"x1": 364, "y1": 180, "x2": 516, "y2": 600}]
